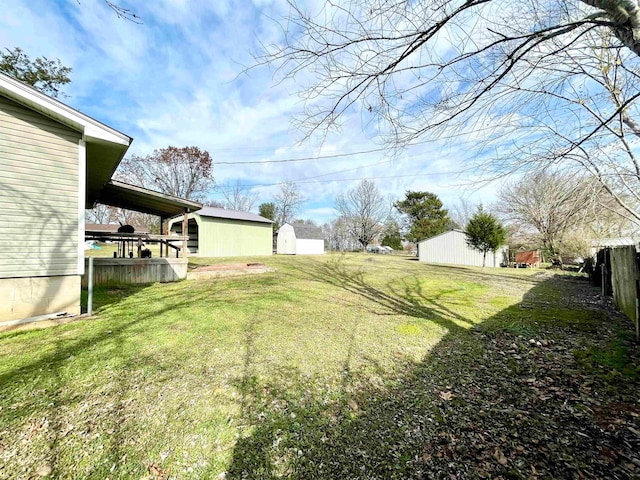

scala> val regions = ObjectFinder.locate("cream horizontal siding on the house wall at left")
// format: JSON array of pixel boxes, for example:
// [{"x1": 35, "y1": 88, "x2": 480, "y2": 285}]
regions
[{"x1": 0, "y1": 97, "x2": 81, "y2": 278}]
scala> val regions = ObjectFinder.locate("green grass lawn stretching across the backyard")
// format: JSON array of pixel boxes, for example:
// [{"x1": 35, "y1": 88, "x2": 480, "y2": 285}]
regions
[{"x1": 0, "y1": 254, "x2": 632, "y2": 479}]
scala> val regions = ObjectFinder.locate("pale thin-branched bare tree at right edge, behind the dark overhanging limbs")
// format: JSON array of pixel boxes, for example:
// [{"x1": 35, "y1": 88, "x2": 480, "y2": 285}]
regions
[{"x1": 488, "y1": 32, "x2": 640, "y2": 223}]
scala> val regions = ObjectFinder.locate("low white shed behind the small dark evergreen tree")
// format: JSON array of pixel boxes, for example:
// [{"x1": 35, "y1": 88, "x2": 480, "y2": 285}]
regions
[{"x1": 418, "y1": 230, "x2": 509, "y2": 267}]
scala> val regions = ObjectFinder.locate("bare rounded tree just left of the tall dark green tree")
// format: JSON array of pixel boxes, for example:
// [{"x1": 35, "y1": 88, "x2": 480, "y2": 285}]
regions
[{"x1": 336, "y1": 180, "x2": 389, "y2": 249}]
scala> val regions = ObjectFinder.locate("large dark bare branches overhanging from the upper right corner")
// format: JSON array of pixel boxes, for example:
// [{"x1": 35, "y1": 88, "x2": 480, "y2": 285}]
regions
[{"x1": 258, "y1": 0, "x2": 640, "y2": 219}]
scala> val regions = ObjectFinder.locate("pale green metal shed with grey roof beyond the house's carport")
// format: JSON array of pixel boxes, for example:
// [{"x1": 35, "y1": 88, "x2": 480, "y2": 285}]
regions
[{"x1": 169, "y1": 207, "x2": 273, "y2": 257}]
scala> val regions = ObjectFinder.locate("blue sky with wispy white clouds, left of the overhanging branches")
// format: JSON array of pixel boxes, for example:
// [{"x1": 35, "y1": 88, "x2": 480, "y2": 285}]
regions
[{"x1": 0, "y1": 0, "x2": 497, "y2": 224}]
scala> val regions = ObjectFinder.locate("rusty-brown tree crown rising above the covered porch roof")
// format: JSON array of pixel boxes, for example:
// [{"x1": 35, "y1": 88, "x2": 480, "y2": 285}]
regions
[{"x1": 116, "y1": 146, "x2": 214, "y2": 201}]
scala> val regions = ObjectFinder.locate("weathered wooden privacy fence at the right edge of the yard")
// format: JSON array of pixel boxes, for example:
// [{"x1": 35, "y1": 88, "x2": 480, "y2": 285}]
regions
[{"x1": 603, "y1": 246, "x2": 640, "y2": 340}]
